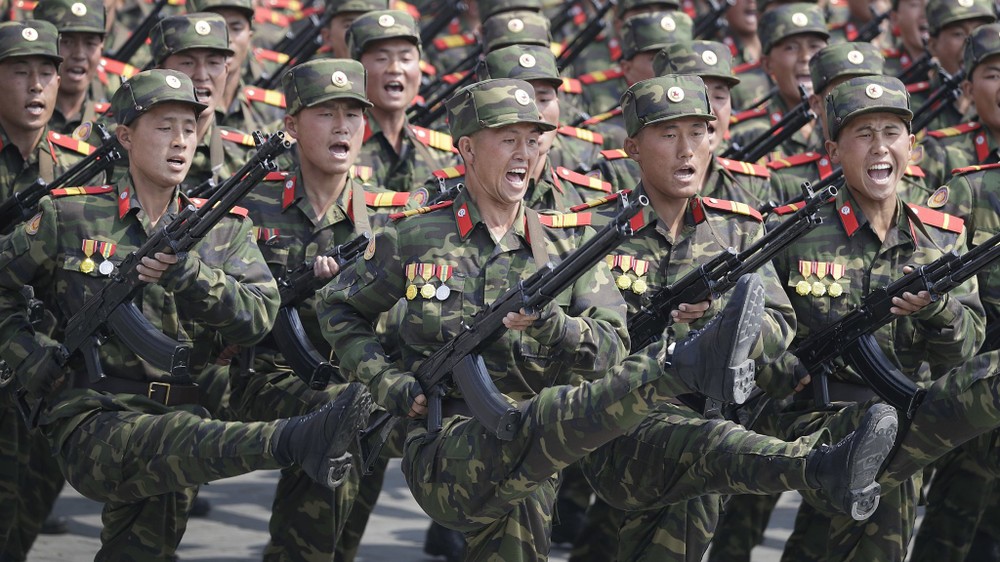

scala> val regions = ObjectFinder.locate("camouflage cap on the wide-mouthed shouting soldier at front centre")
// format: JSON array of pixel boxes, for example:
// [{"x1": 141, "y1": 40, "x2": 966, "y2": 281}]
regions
[{"x1": 445, "y1": 78, "x2": 556, "y2": 141}]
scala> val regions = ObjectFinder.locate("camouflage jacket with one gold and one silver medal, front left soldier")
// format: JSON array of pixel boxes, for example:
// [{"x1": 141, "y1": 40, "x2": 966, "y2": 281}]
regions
[{"x1": 0, "y1": 178, "x2": 278, "y2": 430}]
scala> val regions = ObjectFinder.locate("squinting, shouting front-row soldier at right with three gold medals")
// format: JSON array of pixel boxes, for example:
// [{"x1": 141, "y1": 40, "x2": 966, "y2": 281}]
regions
[{"x1": 757, "y1": 76, "x2": 983, "y2": 561}]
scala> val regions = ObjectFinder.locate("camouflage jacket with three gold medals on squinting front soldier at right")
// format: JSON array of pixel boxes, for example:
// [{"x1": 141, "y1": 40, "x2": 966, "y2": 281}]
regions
[{"x1": 764, "y1": 184, "x2": 984, "y2": 389}]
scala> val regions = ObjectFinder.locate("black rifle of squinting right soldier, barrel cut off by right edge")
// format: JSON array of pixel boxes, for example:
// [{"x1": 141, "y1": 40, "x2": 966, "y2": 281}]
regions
[{"x1": 792, "y1": 226, "x2": 1000, "y2": 418}]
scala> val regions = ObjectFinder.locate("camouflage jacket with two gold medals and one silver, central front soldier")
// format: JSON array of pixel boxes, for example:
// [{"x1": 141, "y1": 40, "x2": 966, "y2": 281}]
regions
[{"x1": 319, "y1": 191, "x2": 628, "y2": 413}]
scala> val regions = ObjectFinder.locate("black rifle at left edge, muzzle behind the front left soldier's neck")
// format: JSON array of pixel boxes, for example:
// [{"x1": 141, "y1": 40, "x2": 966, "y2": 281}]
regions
[{"x1": 0, "y1": 125, "x2": 121, "y2": 234}]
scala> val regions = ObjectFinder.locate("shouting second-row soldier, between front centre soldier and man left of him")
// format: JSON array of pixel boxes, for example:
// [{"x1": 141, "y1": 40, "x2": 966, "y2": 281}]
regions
[{"x1": 347, "y1": 10, "x2": 458, "y2": 191}]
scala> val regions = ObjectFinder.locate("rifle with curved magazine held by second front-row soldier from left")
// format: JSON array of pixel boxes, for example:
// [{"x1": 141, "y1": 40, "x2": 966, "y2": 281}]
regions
[{"x1": 271, "y1": 232, "x2": 371, "y2": 390}]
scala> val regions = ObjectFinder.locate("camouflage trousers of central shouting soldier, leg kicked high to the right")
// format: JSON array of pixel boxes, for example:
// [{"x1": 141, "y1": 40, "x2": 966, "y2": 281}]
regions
[{"x1": 402, "y1": 344, "x2": 696, "y2": 562}]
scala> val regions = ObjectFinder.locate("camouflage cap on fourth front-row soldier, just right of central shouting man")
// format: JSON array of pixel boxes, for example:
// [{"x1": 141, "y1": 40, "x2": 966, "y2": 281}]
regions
[{"x1": 621, "y1": 74, "x2": 715, "y2": 137}]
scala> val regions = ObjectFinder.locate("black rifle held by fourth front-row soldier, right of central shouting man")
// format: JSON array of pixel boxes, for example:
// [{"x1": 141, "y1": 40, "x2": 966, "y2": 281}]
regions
[{"x1": 628, "y1": 185, "x2": 838, "y2": 353}]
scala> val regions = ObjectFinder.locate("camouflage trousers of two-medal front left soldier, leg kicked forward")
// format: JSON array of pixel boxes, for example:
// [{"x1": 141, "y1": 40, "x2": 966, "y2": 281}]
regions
[{"x1": 42, "y1": 400, "x2": 281, "y2": 561}]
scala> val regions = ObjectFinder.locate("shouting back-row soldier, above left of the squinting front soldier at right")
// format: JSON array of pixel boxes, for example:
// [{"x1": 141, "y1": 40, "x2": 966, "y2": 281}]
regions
[{"x1": 732, "y1": 3, "x2": 830, "y2": 160}]
